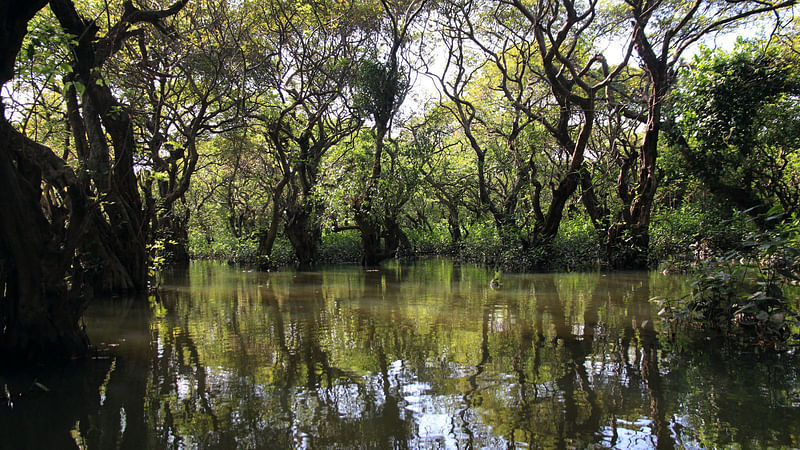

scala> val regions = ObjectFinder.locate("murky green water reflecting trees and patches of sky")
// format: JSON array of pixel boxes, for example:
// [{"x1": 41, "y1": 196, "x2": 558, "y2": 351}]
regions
[{"x1": 0, "y1": 260, "x2": 800, "y2": 449}]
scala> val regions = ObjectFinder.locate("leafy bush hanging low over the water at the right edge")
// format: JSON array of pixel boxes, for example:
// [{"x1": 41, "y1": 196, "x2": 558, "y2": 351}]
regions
[{"x1": 656, "y1": 217, "x2": 800, "y2": 345}]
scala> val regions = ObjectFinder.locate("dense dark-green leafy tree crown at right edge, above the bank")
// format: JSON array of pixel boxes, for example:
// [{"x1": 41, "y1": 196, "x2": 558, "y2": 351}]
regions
[{"x1": 668, "y1": 42, "x2": 800, "y2": 227}]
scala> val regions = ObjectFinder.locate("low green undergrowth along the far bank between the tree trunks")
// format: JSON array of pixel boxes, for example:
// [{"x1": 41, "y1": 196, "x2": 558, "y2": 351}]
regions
[{"x1": 189, "y1": 209, "x2": 749, "y2": 272}]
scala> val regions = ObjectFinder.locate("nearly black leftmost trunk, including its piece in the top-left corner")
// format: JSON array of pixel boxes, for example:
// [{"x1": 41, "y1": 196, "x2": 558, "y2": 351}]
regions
[{"x1": 0, "y1": 0, "x2": 88, "y2": 363}]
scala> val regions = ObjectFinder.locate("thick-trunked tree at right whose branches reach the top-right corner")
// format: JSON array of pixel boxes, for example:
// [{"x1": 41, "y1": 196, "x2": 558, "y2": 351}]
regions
[{"x1": 583, "y1": 0, "x2": 794, "y2": 268}]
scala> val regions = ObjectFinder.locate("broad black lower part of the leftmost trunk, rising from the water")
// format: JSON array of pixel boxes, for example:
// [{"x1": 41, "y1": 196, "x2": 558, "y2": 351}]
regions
[{"x1": 0, "y1": 118, "x2": 88, "y2": 364}]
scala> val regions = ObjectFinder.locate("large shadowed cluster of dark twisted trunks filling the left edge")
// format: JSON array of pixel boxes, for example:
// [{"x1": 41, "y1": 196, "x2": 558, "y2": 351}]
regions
[{"x1": 0, "y1": 0, "x2": 183, "y2": 362}]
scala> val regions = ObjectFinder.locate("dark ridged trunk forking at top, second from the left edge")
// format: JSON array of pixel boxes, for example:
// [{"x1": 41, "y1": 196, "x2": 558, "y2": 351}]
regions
[{"x1": 50, "y1": 0, "x2": 152, "y2": 293}]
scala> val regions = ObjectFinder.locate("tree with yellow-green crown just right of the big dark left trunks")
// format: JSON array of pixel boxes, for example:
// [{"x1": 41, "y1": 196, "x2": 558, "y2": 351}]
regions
[{"x1": 113, "y1": 2, "x2": 247, "y2": 264}]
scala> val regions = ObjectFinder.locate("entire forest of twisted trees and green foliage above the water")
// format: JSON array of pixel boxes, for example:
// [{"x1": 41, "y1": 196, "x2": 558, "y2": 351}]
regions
[{"x1": 0, "y1": 0, "x2": 800, "y2": 364}]
